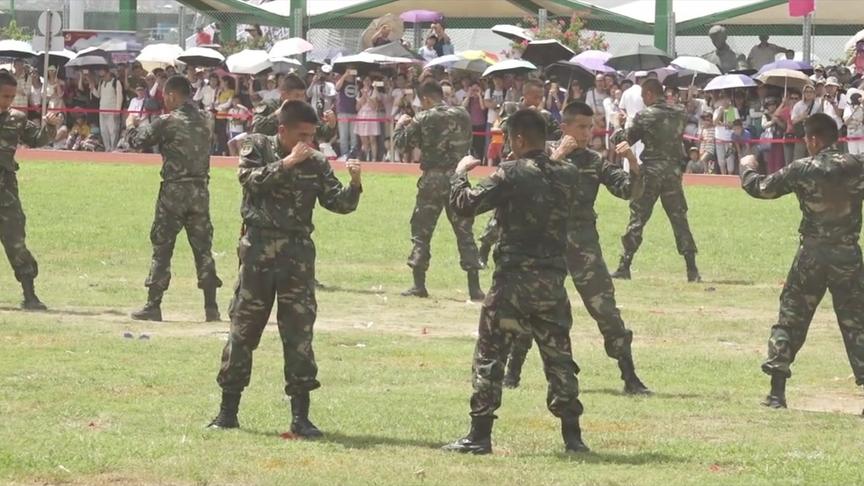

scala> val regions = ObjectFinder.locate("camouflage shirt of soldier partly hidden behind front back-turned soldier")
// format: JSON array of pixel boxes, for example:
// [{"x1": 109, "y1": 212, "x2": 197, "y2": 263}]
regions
[{"x1": 564, "y1": 149, "x2": 644, "y2": 228}]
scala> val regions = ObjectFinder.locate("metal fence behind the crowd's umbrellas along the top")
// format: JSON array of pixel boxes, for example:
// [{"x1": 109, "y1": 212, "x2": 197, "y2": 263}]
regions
[{"x1": 0, "y1": 0, "x2": 848, "y2": 65}]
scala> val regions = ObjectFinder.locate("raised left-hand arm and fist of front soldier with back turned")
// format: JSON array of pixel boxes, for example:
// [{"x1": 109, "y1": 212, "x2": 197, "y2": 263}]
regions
[{"x1": 450, "y1": 155, "x2": 508, "y2": 216}]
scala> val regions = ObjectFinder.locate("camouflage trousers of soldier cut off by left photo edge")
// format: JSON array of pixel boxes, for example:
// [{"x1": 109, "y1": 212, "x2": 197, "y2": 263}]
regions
[{"x1": 0, "y1": 170, "x2": 39, "y2": 282}]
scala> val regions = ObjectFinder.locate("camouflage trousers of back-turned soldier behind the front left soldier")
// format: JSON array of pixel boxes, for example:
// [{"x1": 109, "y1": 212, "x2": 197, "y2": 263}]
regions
[{"x1": 144, "y1": 181, "x2": 222, "y2": 292}]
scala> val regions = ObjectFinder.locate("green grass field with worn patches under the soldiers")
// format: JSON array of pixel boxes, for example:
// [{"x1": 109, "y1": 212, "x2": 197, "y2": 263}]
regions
[{"x1": 0, "y1": 163, "x2": 864, "y2": 486}]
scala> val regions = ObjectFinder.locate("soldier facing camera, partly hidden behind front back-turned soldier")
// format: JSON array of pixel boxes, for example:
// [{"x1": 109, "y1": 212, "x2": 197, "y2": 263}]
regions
[{"x1": 504, "y1": 101, "x2": 650, "y2": 395}]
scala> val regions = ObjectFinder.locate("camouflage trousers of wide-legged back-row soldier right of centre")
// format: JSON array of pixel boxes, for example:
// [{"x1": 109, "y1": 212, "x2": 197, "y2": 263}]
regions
[{"x1": 621, "y1": 169, "x2": 696, "y2": 255}]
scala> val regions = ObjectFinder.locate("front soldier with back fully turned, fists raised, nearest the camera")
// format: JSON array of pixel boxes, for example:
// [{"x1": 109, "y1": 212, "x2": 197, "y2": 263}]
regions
[{"x1": 444, "y1": 110, "x2": 588, "y2": 454}]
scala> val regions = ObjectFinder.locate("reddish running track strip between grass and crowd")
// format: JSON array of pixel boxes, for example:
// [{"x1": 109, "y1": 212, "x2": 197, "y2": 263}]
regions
[{"x1": 17, "y1": 149, "x2": 741, "y2": 187}]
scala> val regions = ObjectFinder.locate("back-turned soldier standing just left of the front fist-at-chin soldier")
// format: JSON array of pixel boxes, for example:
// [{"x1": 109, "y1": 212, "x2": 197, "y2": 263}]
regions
[{"x1": 127, "y1": 75, "x2": 222, "y2": 322}]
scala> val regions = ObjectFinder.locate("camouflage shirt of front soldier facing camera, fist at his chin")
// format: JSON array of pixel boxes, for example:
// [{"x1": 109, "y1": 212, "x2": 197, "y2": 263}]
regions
[{"x1": 238, "y1": 134, "x2": 363, "y2": 236}]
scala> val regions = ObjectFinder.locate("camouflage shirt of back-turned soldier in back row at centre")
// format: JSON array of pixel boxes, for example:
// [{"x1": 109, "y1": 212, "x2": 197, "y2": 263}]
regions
[{"x1": 393, "y1": 105, "x2": 471, "y2": 170}]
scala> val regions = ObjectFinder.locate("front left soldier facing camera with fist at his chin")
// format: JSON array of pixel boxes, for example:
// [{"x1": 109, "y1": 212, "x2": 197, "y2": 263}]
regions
[{"x1": 210, "y1": 101, "x2": 362, "y2": 437}]
